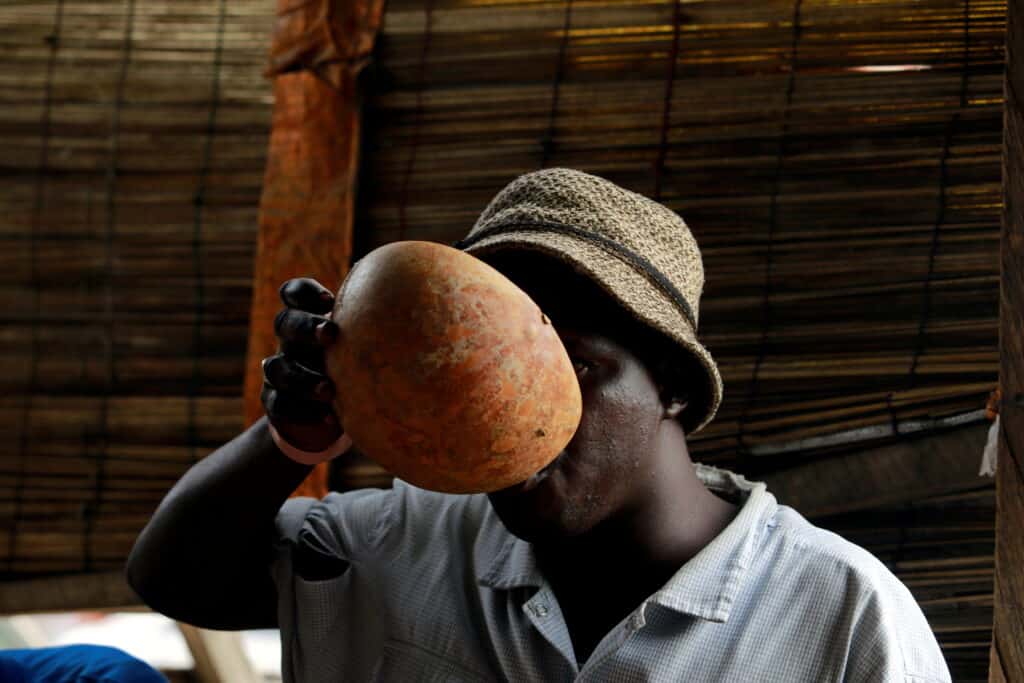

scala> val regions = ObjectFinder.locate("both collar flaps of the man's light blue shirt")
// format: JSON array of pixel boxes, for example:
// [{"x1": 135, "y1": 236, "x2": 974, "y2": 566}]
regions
[{"x1": 474, "y1": 465, "x2": 777, "y2": 622}]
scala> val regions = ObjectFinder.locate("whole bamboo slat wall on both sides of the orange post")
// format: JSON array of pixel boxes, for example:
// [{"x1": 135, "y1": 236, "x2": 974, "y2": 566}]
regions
[{"x1": 0, "y1": 0, "x2": 1006, "y2": 681}]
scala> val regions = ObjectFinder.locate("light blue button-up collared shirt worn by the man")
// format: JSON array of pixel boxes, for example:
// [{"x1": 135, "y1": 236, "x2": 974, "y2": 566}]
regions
[{"x1": 272, "y1": 465, "x2": 950, "y2": 683}]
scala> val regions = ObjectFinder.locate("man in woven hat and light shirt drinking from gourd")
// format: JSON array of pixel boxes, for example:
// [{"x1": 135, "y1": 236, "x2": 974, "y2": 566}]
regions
[{"x1": 128, "y1": 169, "x2": 949, "y2": 683}]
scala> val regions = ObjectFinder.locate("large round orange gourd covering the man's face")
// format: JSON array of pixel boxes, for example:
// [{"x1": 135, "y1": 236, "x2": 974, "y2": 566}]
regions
[{"x1": 327, "y1": 242, "x2": 582, "y2": 494}]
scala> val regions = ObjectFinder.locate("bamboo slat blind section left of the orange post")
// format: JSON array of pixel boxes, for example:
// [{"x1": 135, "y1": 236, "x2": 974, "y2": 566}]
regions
[{"x1": 0, "y1": 0, "x2": 272, "y2": 578}]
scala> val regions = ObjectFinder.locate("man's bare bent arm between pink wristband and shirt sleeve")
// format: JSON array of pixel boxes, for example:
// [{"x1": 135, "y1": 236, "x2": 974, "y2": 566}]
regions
[{"x1": 127, "y1": 419, "x2": 311, "y2": 628}]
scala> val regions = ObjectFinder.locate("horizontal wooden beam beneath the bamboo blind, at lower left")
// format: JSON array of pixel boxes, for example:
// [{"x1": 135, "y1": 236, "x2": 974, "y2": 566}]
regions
[{"x1": 0, "y1": 571, "x2": 142, "y2": 614}]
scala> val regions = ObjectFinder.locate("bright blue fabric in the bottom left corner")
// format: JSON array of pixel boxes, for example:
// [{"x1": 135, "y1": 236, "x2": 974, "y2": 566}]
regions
[{"x1": 0, "y1": 645, "x2": 167, "y2": 683}]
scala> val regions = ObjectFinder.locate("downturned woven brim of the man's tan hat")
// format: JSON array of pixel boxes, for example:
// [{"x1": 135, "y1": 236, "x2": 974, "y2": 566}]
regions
[{"x1": 465, "y1": 230, "x2": 722, "y2": 433}]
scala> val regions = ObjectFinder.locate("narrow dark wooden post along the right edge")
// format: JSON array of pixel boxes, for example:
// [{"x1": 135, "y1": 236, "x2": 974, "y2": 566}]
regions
[{"x1": 989, "y1": 0, "x2": 1024, "y2": 682}]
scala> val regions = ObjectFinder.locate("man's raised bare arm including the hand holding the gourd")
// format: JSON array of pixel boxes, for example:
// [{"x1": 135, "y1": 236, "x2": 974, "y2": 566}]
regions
[{"x1": 127, "y1": 279, "x2": 341, "y2": 629}]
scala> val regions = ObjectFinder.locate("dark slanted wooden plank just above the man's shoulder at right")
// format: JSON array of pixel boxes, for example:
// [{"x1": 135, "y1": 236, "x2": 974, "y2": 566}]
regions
[{"x1": 764, "y1": 423, "x2": 992, "y2": 517}]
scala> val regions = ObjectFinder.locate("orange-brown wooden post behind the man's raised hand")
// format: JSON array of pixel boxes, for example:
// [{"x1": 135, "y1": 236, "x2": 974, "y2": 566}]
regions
[{"x1": 245, "y1": 0, "x2": 383, "y2": 496}]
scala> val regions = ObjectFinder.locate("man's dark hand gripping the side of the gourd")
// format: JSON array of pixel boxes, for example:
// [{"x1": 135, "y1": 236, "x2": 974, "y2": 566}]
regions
[{"x1": 260, "y1": 278, "x2": 341, "y2": 452}]
